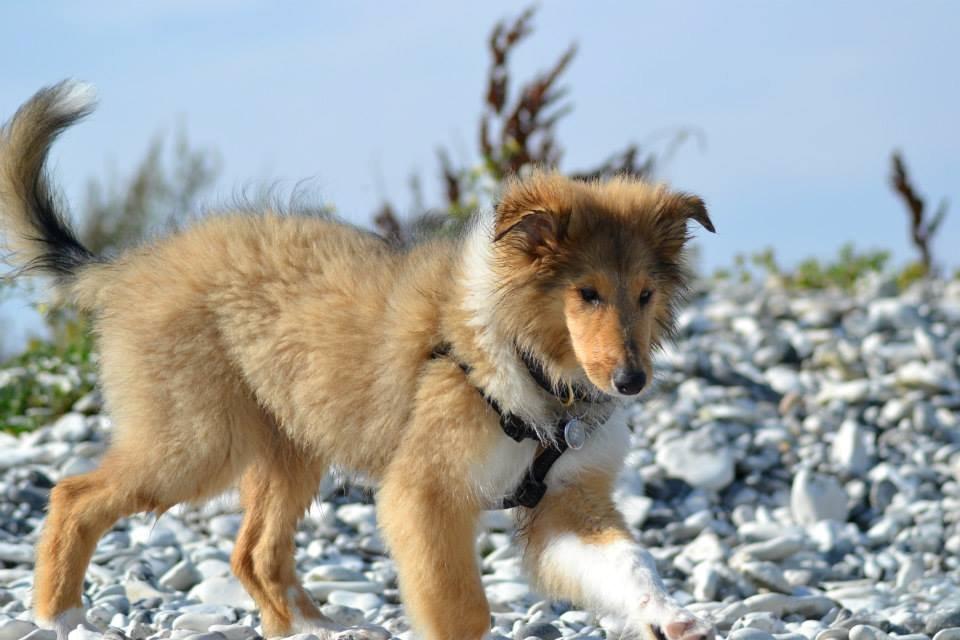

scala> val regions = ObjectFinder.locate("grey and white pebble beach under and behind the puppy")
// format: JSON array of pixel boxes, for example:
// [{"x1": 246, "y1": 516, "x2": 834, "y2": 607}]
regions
[{"x1": 0, "y1": 276, "x2": 960, "y2": 640}]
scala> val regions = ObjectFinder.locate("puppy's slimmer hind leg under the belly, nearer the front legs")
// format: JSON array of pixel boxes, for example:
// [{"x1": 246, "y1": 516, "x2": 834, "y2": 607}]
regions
[{"x1": 231, "y1": 435, "x2": 340, "y2": 638}]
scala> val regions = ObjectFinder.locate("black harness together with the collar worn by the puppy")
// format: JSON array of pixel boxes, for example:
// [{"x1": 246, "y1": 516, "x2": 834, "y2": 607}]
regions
[{"x1": 430, "y1": 342, "x2": 595, "y2": 509}]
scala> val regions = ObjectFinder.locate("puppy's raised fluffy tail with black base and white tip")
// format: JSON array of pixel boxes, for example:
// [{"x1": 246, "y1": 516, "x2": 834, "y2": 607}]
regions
[{"x1": 0, "y1": 81, "x2": 97, "y2": 285}]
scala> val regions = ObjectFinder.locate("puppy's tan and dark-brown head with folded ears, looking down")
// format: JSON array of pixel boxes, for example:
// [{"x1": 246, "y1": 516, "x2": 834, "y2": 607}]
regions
[{"x1": 494, "y1": 173, "x2": 714, "y2": 396}]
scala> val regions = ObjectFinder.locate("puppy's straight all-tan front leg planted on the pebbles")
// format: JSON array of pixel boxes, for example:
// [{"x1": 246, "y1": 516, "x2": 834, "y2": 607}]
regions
[{"x1": 377, "y1": 472, "x2": 490, "y2": 640}]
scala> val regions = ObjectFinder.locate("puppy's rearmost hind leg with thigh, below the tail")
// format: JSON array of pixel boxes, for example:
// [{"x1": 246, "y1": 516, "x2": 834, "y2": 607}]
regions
[{"x1": 33, "y1": 382, "x2": 267, "y2": 639}]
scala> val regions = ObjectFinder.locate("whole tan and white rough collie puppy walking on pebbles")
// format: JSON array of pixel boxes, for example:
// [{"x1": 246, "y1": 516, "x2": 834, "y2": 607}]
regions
[{"x1": 0, "y1": 83, "x2": 713, "y2": 640}]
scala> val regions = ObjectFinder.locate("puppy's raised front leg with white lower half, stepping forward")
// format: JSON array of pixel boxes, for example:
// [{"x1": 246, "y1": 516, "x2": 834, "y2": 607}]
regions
[{"x1": 524, "y1": 472, "x2": 714, "y2": 640}]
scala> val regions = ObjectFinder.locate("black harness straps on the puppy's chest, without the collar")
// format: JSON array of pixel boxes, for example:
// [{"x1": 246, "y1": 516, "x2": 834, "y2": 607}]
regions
[{"x1": 430, "y1": 342, "x2": 570, "y2": 509}]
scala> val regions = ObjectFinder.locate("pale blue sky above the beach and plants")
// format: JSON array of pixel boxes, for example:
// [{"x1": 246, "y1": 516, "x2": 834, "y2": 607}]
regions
[{"x1": 0, "y1": 0, "x2": 960, "y2": 344}]
